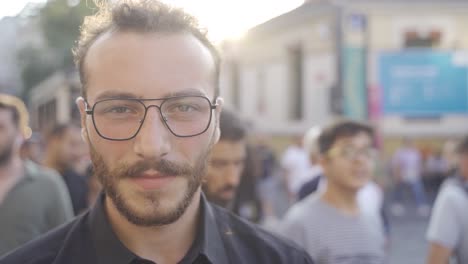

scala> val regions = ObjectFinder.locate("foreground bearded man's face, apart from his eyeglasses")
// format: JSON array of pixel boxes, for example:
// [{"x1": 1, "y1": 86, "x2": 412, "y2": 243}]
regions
[{"x1": 78, "y1": 32, "x2": 222, "y2": 226}]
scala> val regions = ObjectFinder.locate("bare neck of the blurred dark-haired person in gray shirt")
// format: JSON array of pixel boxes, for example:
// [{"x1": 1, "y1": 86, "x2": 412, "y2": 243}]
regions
[{"x1": 322, "y1": 181, "x2": 359, "y2": 215}]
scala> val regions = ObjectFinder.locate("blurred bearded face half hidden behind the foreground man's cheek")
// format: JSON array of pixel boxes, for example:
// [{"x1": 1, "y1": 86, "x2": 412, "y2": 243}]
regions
[{"x1": 203, "y1": 140, "x2": 246, "y2": 207}]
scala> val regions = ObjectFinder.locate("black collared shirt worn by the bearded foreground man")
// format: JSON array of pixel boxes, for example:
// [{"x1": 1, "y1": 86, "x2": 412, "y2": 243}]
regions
[{"x1": 0, "y1": 192, "x2": 313, "y2": 264}]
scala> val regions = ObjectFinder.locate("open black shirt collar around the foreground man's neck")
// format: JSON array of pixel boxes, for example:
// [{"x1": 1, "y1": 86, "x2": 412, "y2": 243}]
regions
[{"x1": 89, "y1": 193, "x2": 228, "y2": 264}]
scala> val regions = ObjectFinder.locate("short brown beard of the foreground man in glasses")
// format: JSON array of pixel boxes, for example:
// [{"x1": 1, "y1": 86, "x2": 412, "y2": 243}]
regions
[{"x1": 90, "y1": 144, "x2": 212, "y2": 227}]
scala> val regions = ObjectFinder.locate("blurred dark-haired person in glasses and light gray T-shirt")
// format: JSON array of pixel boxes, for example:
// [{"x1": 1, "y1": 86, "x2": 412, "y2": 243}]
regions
[{"x1": 280, "y1": 121, "x2": 386, "y2": 264}]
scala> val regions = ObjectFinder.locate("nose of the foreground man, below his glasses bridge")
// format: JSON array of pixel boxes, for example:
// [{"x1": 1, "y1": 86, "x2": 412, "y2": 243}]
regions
[{"x1": 134, "y1": 106, "x2": 171, "y2": 159}]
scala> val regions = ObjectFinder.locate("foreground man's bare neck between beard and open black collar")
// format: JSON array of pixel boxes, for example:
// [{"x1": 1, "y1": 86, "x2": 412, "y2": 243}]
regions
[{"x1": 105, "y1": 190, "x2": 201, "y2": 263}]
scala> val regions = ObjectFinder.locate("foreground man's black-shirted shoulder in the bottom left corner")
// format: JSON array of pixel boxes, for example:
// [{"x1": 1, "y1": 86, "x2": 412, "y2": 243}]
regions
[{"x1": 0, "y1": 216, "x2": 84, "y2": 264}]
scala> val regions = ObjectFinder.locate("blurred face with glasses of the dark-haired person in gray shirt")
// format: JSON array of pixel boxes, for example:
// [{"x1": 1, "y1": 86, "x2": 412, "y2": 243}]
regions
[{"x1": 321, "y1": 132, "x2": 375, "y2": 192}]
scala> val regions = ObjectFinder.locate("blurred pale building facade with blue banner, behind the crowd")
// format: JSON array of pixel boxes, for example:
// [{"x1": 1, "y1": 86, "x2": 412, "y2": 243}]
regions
[{"x1": 221, "y1": 0, "x2": 468, "y2": 138}]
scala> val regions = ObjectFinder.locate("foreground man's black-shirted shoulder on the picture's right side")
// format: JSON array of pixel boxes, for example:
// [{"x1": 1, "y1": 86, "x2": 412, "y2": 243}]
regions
[{"x1": 214, "y1": 208, "x2": 312, "y2": 263}]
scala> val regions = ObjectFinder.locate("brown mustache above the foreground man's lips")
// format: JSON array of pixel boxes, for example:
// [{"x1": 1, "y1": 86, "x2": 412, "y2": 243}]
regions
[{"x1": 117, "y1": 159, "x2": 193, "y2": 178}]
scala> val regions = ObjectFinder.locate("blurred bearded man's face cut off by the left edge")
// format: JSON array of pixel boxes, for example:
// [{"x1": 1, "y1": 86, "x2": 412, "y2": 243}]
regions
[{"x1": 0, "y1": 109, "x2": 19, "y2": 167}]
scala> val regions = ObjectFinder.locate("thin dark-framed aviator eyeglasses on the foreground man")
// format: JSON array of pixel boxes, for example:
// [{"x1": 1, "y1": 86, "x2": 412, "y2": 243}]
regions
[{"x1": 86, "y1": 96, "x2": 218, "y2": 141}]
